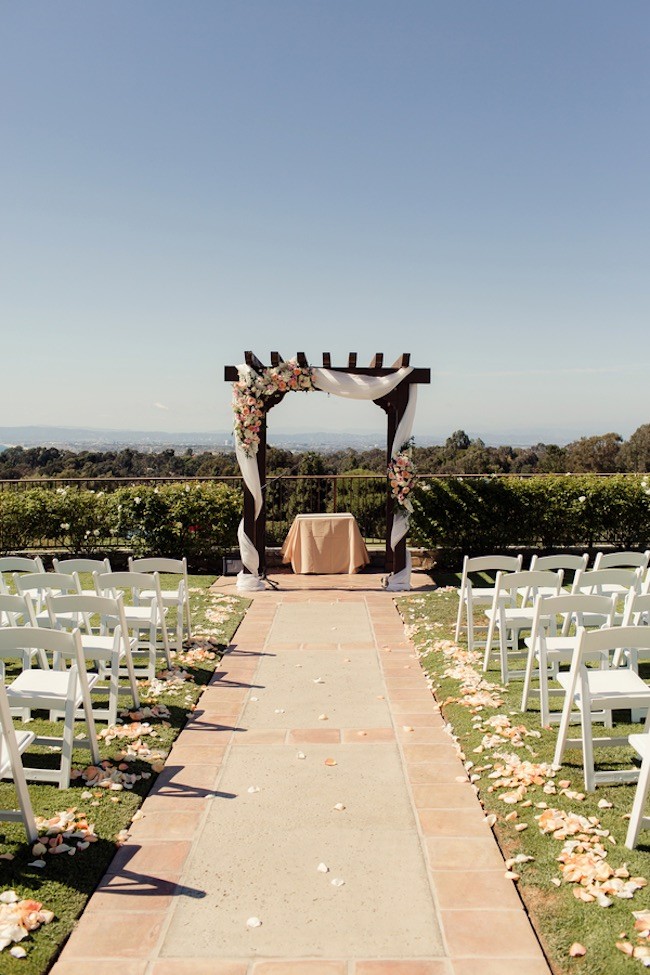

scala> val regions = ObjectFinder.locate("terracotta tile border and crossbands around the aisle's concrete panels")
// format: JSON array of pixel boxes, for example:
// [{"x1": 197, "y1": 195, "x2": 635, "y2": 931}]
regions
[{"x1": 52, "y1": 574, "x2": 549, "y2": 975}]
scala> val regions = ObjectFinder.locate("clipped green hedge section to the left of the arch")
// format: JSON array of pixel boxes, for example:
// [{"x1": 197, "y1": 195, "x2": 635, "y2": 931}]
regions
[{"x1": 0, "y1": 483, "x2": 242, "y2": 561}]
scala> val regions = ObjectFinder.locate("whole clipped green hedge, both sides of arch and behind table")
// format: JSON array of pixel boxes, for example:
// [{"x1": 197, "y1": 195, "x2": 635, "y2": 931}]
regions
[{"x1": 0, "y1": 474, "x2": 650, "y2": 562}]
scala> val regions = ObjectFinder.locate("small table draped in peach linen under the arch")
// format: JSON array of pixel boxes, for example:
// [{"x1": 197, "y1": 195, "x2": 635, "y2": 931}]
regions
[{"x1": 282, "y1": 513, "x2": 370, "y2": 575}]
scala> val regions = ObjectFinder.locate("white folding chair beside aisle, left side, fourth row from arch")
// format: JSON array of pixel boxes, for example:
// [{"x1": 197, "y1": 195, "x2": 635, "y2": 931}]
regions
[{"x1": 0, "y1": 626, "x2": 99, "y2": 789}]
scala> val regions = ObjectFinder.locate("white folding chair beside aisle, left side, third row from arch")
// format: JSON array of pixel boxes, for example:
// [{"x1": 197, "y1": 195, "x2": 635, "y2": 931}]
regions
[{"x1": 45, "y1": 594, "x2": 140, "y2": 724}]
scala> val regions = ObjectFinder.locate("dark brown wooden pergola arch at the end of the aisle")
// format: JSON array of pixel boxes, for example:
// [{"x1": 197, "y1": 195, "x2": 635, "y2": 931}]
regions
[{"x1": 224, "y1": 352, "x2": 431, "y2": 575}]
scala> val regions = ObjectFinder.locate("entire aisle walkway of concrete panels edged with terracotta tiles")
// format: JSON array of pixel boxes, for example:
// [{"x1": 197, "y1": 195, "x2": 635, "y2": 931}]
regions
[{"x1": 52, "y1": 574, "x2": 549, "y2": 975}]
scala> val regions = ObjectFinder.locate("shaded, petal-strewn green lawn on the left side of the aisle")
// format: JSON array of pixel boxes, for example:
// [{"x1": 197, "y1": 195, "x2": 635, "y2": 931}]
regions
[{"x1": 0, "y1": 576, "x2": 249, "y2": 975}]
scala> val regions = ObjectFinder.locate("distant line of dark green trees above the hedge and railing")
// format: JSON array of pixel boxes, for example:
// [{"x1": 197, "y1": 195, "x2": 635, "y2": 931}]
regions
[{"x1": 0, "y1": 423, "x2": 650, "y2": 480}]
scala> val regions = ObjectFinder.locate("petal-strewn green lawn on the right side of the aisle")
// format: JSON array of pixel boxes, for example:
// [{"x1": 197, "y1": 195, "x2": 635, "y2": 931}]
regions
[{"x1": 398, "y1": 574, "x2": 650, "y2": 975}]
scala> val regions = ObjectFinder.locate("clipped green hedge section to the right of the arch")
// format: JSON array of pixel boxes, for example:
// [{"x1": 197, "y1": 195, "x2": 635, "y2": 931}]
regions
[{"x1": 411, "y1": 474, "x2": 650, "y2": 553}]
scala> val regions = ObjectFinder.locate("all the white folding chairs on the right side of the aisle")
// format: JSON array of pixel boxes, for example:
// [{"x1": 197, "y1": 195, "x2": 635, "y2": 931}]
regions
[{"x1": 459, "y1": 553, "x2": 650, "y2": 848}]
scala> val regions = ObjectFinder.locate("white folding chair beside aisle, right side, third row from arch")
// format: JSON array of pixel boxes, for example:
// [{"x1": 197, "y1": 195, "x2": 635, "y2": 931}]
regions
[{"x1": 521, "y1": 593, "x2": 616, "y2": 728}]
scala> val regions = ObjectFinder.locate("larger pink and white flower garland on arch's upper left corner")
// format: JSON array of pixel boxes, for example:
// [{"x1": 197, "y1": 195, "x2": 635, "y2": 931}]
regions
[{"x1": 232, "y1": 359, "x2": 316, "y2": 457}]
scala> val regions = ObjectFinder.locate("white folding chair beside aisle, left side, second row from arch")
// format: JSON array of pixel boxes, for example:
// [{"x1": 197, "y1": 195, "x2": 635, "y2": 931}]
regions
[{"x1": 93, "y1": 572, "x2": 172, "y2": 678}]
